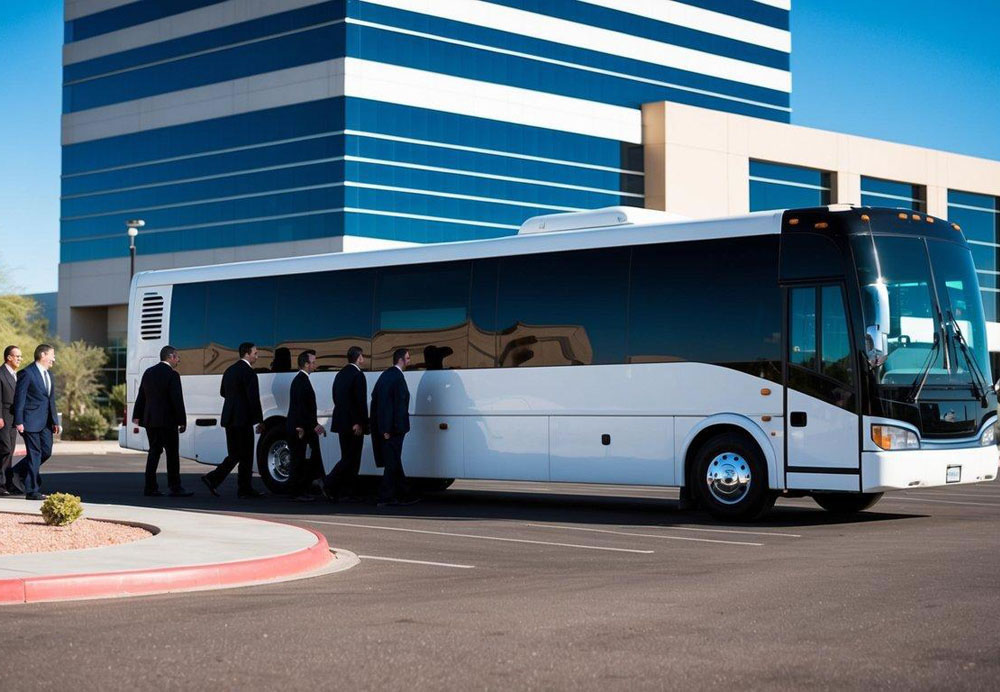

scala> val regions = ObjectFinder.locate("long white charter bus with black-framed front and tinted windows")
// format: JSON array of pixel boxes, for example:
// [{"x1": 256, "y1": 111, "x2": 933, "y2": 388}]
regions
[{"x1": 121, "y1": 206, "x2": 998, "y2": 519}]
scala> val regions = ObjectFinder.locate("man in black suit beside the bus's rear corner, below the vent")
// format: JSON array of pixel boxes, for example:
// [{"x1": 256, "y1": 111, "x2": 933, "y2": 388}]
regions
[{"x1": 132, "y1": 346, "x2": 194, "y2": 497}]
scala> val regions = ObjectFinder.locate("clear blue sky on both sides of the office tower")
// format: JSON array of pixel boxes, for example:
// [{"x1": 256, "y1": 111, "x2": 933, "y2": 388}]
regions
[{"x1": 0, "y1": 0, "x2": 1000, "y2": 292}]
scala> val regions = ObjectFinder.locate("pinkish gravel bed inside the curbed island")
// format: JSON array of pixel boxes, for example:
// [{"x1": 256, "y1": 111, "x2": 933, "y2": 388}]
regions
[{"x1": 0, "y1": 512, "x2": 153, "y2": 555}]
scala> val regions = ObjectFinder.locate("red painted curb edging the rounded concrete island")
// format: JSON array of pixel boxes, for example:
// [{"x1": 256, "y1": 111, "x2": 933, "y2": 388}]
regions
[{"x1": 0, "y1": 527, "x2": 333, "y2": 604}]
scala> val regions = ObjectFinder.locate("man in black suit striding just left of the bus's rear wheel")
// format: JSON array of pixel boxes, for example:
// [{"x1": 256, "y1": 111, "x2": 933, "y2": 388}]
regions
[{"x1": 201, "y1": 342, "x2": 264, "y2": 500}]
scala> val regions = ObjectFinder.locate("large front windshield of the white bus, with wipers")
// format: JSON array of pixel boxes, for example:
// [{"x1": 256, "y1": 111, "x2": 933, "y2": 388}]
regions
[{"x1": 855, "y1": 235, "x2": 991, "y2": 388}]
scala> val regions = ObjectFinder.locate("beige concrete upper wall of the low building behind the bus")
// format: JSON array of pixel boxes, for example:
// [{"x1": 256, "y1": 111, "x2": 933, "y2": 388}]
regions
[{"x1": 642, "y1": 103, "x2": 1000, "y2": 218}]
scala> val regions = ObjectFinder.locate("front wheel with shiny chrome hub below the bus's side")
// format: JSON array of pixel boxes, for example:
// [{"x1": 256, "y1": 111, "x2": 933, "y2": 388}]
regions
[{"x1": 688, "y1": 433, "x2": 778, "y2": 521}]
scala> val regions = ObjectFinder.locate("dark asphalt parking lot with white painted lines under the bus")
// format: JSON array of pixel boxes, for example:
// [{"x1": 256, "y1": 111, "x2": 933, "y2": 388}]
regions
[{"x1": 0, "y1": 454, "x2": 1000, "y2": 690}]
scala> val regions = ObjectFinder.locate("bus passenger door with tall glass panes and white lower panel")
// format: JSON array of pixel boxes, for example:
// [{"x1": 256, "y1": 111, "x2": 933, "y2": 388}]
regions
[{"x1": 784, "y1": 283, "x2": 861, "y2": 490}]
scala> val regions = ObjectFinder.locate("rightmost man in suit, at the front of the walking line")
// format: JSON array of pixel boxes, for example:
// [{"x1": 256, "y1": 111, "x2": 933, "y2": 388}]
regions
[{"x1": 372, "y1": 348, "x2": 419, "y2": 507}]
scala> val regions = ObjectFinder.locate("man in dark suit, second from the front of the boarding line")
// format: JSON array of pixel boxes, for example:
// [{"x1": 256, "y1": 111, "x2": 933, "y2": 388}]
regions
[{"x1": 324, "y1": 346, "x2": 368, "y2": 501}]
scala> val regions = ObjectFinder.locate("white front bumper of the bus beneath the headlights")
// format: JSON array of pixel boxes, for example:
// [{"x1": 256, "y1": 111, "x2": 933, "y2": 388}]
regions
[{"x1": 861, "y1": 445, "x2": 1000, "y2": 493}]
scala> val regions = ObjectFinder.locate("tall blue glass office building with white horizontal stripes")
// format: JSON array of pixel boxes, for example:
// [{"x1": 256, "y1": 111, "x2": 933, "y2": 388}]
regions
[{"x1": 60, "y1": 0, "x2": 791, "y2": 335}]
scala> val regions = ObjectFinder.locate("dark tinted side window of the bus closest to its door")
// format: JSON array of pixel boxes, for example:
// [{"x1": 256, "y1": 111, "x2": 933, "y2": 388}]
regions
[{"x1": 629, "y1": 235, "x2": 781, "y2": 382}]
